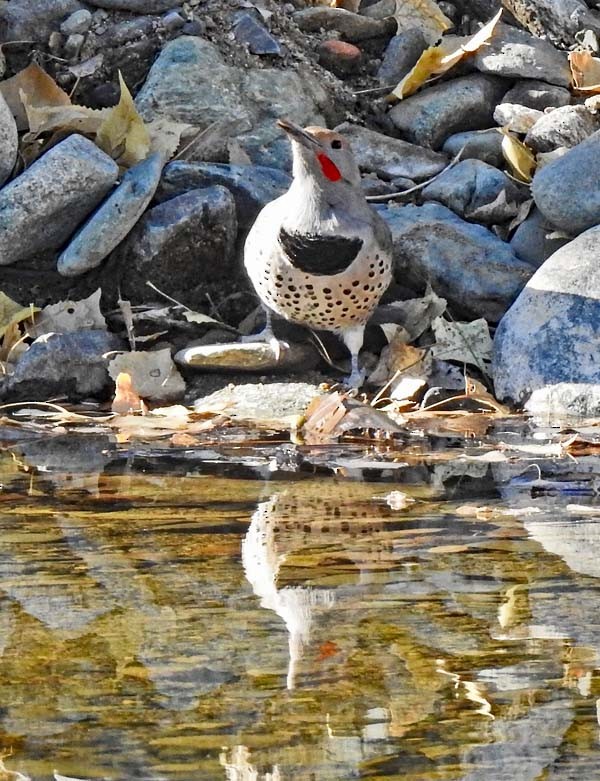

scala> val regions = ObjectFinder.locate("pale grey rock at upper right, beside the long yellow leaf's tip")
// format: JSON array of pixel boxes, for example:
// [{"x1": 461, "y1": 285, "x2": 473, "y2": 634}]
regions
[{"x1": 473, "y1": 22, "x2": 571, "y2": 87}]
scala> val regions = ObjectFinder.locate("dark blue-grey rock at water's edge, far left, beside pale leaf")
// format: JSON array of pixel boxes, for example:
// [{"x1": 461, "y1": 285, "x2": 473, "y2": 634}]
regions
[{"x1": 8, "y1": 330, "x2": 123, "y2": 401}]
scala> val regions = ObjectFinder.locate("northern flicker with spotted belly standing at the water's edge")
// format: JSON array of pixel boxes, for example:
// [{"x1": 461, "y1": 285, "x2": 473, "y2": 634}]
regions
[{"x1": 244, "y1": 119, "x2": 392, "y2": 387}]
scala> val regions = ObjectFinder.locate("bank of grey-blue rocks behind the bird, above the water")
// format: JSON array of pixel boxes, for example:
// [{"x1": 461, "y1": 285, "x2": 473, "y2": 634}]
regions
[{"x1": 0, "y1": 0, "x2": 600, "y2": 417}]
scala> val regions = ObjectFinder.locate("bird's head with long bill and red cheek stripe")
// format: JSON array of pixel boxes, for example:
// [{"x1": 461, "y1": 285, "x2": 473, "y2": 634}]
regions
[{"x1": 277, "y1": 119, "x2": 360, "y2": 189}]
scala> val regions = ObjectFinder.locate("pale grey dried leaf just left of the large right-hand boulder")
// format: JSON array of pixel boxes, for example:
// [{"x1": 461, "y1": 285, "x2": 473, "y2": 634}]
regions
[{"x1": 431, "y1": 317, "x2": 492, "y2": 374}]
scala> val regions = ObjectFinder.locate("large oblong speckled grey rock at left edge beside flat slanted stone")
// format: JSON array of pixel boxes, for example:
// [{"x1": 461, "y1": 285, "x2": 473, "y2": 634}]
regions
[{"x1": 0, "y1": 135, "x2": 119, "y2": 265}]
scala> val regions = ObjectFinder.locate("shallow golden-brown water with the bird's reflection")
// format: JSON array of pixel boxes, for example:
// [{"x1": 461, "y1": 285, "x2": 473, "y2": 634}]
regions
[{"x1": 0, "y1": 432, "x2": 600, "y2": 781}]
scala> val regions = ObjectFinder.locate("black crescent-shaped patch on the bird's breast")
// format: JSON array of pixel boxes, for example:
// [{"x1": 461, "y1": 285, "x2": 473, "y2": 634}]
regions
[{"x1": 279, "y1": 228, "x2": 363, "y2": 276}]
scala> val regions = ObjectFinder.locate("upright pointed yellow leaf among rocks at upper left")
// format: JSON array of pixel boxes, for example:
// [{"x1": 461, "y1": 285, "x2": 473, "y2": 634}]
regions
[{"x1": 96, "y1": 73, "x2": 150, "y2": 168}]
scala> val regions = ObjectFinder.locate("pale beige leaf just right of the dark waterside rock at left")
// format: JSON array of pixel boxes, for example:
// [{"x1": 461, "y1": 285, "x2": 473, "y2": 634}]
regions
[{"x1": 108, "y1": 347, "x2": 185, "y2": 401}]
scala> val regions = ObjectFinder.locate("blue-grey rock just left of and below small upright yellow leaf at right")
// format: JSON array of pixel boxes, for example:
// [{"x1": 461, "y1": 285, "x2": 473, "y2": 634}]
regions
[{"x1": 421, "y1": 160, "x2": 527, "y2": 225}]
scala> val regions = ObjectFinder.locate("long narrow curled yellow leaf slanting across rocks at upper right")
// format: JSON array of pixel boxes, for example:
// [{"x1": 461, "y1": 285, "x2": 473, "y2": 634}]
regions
[{"x1": 392, "y1": 9, "x2": 502, "y2": 100}]
